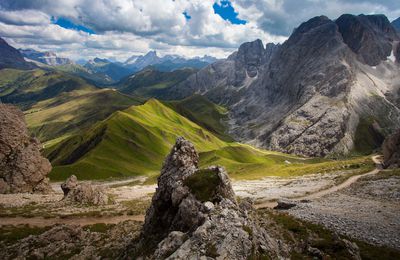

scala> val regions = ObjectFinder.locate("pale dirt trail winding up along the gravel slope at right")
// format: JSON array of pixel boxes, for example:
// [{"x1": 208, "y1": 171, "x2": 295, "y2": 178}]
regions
[{"x1": 255, "y1": 155, "x2": 382, "y2": 209}]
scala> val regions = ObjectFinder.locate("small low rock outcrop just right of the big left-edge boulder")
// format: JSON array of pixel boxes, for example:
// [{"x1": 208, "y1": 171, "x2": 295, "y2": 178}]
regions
[{"x1": 61, "y1": 175, "x2": 108, "y2": 205}]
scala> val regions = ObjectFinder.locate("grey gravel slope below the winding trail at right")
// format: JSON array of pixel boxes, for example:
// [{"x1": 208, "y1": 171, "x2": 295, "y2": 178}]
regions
[{"x1": 288, "y1": 172, "x2": 400, "y2": 249}]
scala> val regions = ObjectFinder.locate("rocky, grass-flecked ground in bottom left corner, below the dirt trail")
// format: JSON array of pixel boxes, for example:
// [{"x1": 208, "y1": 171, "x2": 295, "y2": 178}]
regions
[{"x1": 0, "y1": 221, "x2": 140, "y2": 259}]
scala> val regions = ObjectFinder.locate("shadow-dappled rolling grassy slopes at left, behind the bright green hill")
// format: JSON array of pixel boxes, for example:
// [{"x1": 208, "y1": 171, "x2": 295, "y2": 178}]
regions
[{"x1": 0, "y1": 69, "x2": 141, "y2": 145}]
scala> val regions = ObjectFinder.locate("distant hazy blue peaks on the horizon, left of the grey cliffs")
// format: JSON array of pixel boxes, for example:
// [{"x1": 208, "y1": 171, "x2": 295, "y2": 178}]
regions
[{"x1": 123, "y1": 51, "x2": 217, "y2": 71}]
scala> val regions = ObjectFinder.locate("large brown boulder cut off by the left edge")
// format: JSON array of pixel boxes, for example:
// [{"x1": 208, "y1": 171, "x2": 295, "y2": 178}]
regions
[{"x1": 0, "y1": 104, "x2": 52, "y2": 194}]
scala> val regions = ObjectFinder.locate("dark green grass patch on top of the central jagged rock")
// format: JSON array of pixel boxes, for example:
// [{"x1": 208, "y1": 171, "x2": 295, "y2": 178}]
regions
[{"x1": 184, "y1": 169, "x2": 219, "y2": 202}]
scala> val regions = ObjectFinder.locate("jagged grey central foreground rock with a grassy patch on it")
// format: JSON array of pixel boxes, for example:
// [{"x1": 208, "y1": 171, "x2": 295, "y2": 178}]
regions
[{"x1": 133, "y1": 137, "x2": 278, "y2": 259}]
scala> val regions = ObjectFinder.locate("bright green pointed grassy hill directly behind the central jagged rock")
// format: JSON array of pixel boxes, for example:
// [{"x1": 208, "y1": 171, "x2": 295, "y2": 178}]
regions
[{"x1": 46, "y1": 99, "x2": 227, "y2": 179}]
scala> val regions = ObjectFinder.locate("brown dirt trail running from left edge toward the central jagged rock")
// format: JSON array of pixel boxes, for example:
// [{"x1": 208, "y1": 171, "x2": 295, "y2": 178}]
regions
[{"x1": 0, "y1": 215, "x2": 144, "y2": 227}]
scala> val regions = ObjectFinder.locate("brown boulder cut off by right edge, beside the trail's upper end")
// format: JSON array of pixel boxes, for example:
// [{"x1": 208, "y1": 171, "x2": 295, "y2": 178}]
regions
[{"x1": 382, "y1": 129, "x2": 400, "y2": 168}]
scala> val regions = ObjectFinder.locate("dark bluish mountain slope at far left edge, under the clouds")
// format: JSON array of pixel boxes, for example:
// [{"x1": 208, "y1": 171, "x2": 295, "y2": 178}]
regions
[{"x1": 0, "y1": 38, "x2": 35, "y2": 69}]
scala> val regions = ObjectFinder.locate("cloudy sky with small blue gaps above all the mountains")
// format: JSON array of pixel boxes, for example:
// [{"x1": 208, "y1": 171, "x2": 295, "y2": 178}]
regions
[{"x1": 0, "y1": 0, "x2": 400, "y2": 61}]
